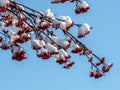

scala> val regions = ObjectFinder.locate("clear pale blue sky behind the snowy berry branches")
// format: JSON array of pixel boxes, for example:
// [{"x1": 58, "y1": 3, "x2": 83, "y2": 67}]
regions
[{"x1": 0, "y1": 0, "x2": 120, "y2": 90}]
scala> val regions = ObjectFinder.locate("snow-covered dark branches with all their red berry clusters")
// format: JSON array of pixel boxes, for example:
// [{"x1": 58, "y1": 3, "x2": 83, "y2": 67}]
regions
[{"x1": 0, "y1": 0, "x2": 113, "y2": 78}]
